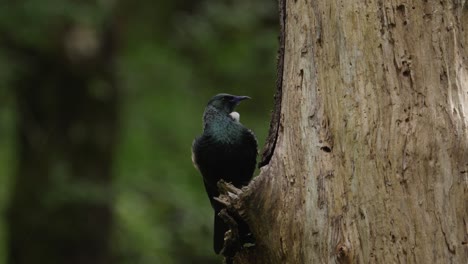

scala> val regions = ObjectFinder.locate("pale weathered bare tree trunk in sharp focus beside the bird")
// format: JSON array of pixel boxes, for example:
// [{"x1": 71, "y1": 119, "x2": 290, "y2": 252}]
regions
[{"x1": 228, "y1": 0, "x2": 468, "y2": 263}]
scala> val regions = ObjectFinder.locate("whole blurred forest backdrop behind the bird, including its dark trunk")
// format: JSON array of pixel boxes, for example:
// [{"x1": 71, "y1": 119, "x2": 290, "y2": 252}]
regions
[{"x1": 0, "y1": 0, "x2": 278, "y2": 264}]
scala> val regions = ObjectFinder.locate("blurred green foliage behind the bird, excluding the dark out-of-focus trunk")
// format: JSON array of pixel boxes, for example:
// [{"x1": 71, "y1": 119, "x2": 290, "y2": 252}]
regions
[{"x1": 0, "y1": 0, "x2": 278, "y2": 264}]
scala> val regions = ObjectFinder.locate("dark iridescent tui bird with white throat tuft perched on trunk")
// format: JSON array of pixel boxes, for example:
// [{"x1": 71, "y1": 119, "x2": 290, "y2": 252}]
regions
[{"x1": 192, "y1": 94, "x2": 257, "y2": 254}]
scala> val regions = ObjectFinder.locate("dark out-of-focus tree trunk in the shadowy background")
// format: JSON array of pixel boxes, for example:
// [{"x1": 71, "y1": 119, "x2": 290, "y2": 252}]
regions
[{"x1": 3, "y1": 7, "x2": 119, "y2": 264}]
